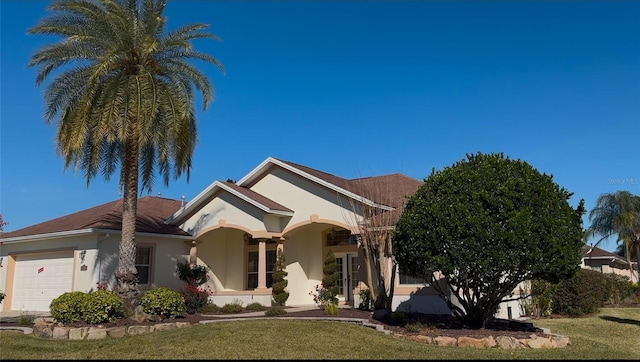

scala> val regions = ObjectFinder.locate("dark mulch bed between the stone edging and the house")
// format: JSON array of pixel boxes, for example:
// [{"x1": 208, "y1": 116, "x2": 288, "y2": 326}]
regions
[{"x1": 0, "y1": 308, "x2": 543, "y2": 338}]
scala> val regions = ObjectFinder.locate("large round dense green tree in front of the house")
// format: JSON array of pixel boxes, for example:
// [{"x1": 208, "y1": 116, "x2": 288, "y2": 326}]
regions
[{"x1": 393, "y1": 153, "x2": 585, "y2": 328}]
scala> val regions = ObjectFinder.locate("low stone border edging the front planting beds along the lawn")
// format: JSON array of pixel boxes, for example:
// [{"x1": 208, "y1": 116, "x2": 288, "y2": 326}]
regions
[{"x1": 0, "y1": 317, "x2": 571, "y2": 349}]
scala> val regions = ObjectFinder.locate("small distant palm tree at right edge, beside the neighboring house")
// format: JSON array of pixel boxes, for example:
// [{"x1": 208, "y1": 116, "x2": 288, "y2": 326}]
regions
[{"x1": 585, "y1": 191, "x2": 640, "y2": 281}]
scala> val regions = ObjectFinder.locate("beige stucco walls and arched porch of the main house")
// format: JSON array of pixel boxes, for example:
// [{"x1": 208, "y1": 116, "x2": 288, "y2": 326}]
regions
[{"x1": 0, "y1": 159, "x2": 544, "y2": 318}]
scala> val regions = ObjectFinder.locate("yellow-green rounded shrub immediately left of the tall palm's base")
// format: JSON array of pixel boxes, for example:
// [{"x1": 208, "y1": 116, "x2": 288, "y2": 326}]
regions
[{"x1": 81, "y1": 290, "x2": 124, "y2": 324}]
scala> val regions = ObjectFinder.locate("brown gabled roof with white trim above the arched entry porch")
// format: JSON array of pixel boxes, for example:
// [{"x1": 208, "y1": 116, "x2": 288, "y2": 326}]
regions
[{"x1": 167, "y1": 157, "x2": 422, "y2": 224}]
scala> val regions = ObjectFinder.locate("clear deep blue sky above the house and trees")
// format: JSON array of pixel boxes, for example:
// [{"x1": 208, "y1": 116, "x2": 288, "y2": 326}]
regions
[{"x1": 0, "y1": 0, "x2": 640, "y2": 250}]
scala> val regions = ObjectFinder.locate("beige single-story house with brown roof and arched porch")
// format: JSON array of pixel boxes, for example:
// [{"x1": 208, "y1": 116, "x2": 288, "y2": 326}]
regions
[{"x1": 0, "y1": 157, "x2": 521, "y2": 318}]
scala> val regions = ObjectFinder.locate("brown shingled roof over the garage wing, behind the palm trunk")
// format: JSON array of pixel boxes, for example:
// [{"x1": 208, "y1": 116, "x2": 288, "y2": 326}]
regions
[{"x1": 1, "y1": 196, "x2": 190, "y2": 241}]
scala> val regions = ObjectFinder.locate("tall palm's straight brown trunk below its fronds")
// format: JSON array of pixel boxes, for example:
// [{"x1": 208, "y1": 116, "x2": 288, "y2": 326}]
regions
[{"x1": 114, "y1": 137, "x2": 139, "y2": 309}]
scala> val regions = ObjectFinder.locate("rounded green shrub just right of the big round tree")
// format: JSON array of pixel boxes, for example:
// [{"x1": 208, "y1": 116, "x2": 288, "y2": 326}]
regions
[{"x1": 552, "y1": 269, "x2": 608, "y2": 317}]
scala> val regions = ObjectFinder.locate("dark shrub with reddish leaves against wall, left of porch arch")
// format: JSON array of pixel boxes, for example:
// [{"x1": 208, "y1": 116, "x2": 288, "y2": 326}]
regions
[{"x1": 176, "y1": 261, "x2": 213, "y2": 314}]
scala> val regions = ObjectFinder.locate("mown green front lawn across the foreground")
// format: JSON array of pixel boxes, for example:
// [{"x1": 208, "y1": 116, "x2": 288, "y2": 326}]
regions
[{"x1": 0, "y1": 308, "x2": 640, "y2": 360}]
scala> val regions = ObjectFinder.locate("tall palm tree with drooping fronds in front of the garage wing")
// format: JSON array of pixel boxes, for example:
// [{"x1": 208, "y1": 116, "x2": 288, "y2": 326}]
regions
[{"x1": 28, "y1": 0, "x2": 224, "y2": 301}]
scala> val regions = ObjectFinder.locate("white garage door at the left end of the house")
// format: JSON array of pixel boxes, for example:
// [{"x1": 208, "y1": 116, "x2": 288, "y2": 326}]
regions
[{"x1": 11, "y1": 250, "x2": 73, "y2": 311}]
